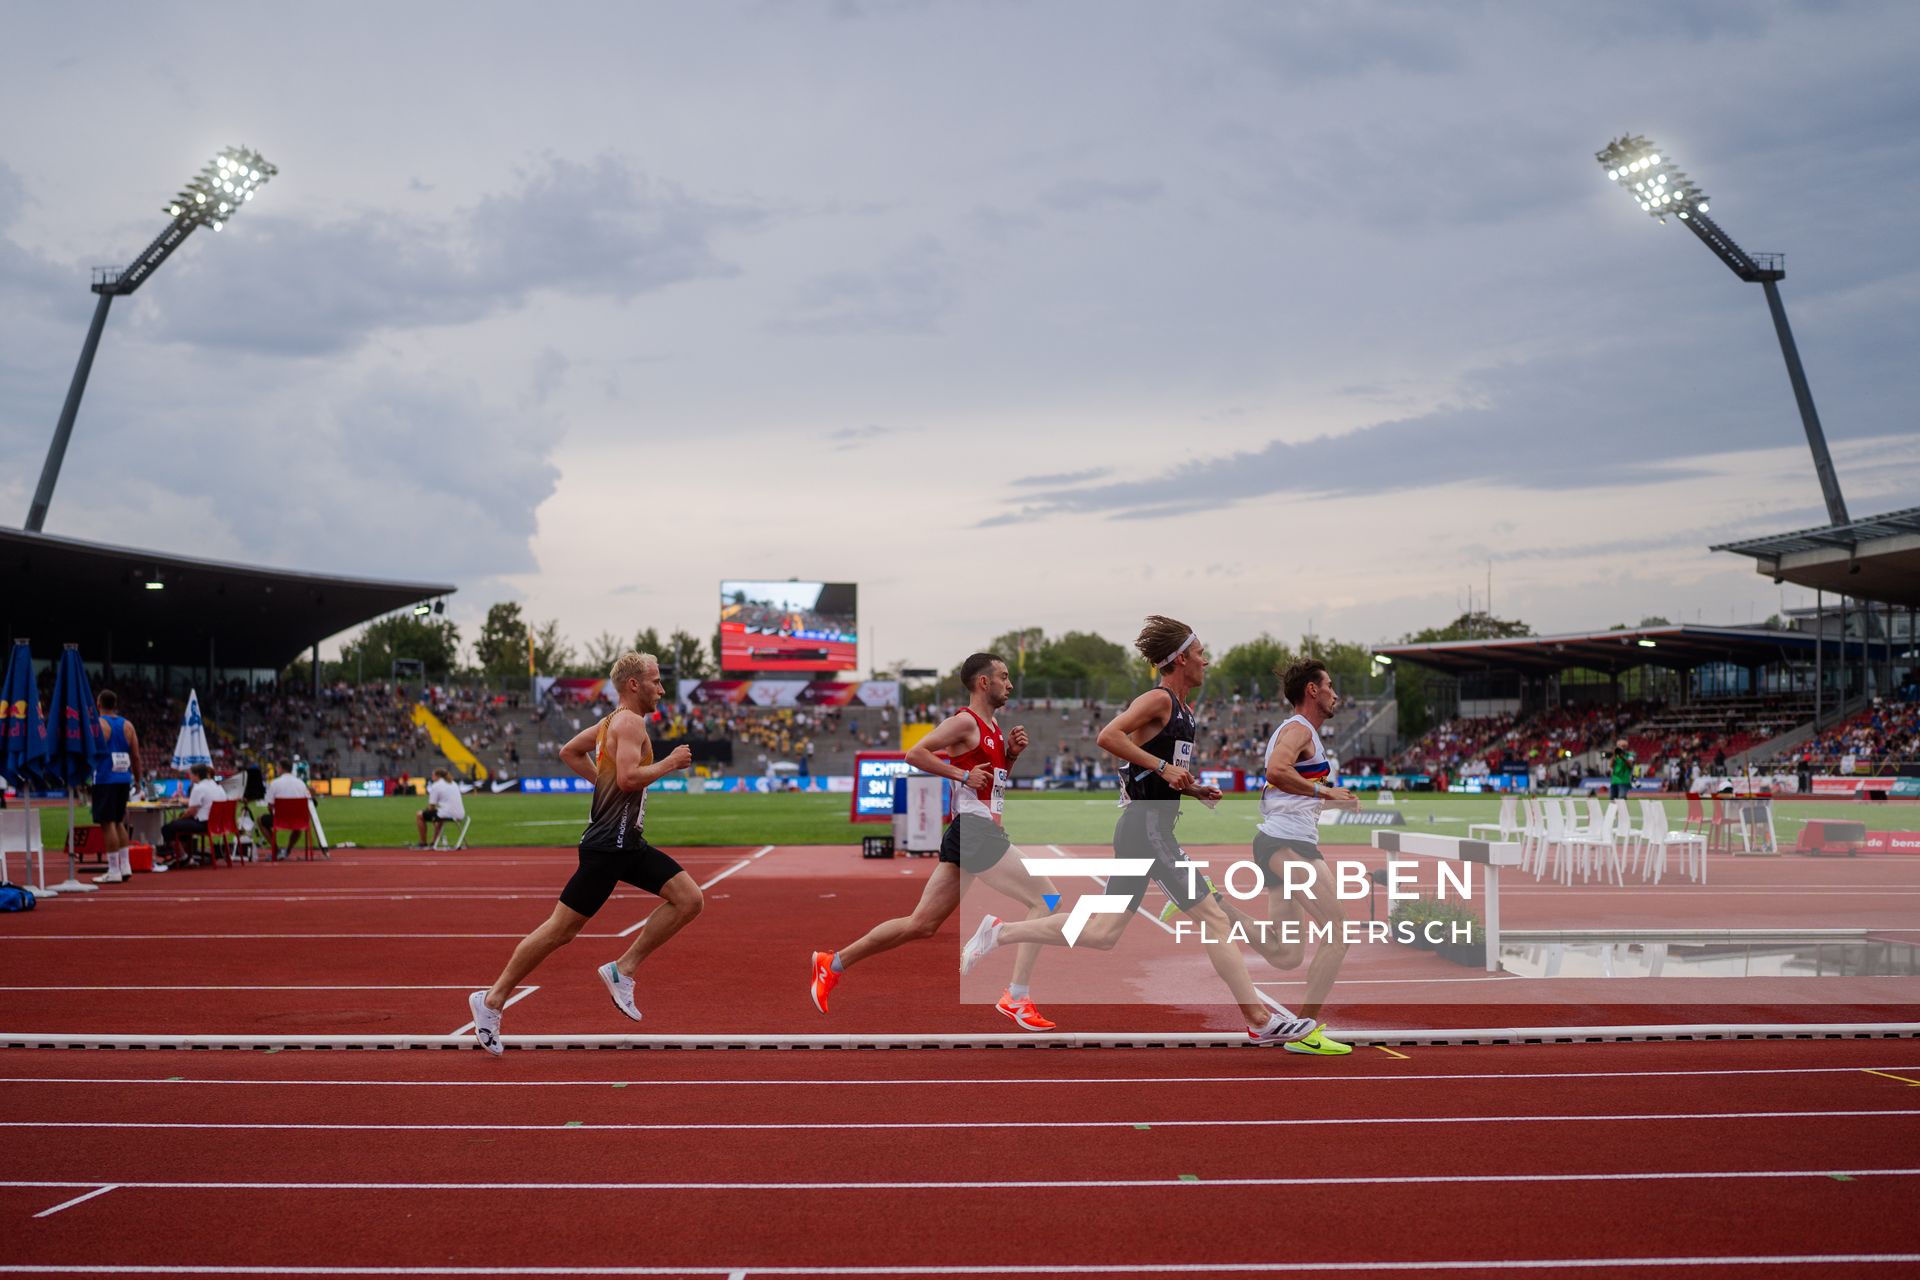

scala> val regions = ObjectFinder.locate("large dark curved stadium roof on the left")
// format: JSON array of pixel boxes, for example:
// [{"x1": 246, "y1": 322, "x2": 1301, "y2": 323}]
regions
[{"x1": 0, "y1": 530, "x2": 453, "y2": 668}]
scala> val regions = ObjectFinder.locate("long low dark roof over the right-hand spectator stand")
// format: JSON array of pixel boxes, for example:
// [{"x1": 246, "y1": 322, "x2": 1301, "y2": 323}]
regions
[{"x1": 1375, "y1": 624, "x2": 1860, "y2": 676}]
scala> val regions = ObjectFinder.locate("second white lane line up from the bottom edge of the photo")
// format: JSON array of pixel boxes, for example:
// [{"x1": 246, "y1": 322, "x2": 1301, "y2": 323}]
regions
[{"x1": 0, "y1": 1167, "x2": 1920, "y2": 1197}]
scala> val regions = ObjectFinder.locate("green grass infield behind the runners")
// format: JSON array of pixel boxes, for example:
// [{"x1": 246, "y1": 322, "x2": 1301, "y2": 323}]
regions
[{"x1": 30, "y1": 791, "x2": 1920, "y2": 848}]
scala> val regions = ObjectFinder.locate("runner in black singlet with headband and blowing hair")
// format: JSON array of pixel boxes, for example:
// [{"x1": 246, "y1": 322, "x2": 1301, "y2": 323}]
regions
[{"x1": 960, "y1": 614, "x2": 1313, "y2": 1044}]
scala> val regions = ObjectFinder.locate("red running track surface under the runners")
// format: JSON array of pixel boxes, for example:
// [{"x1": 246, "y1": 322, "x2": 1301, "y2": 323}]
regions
[{"x1": 0, "y1": 848, "x2": 1920, "y2": 1278}]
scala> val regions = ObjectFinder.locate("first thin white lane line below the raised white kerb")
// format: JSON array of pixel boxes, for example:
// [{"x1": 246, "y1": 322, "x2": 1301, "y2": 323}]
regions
[{"x1": 0, "y1": 1065, "x2": 1920, "y2": 1090}]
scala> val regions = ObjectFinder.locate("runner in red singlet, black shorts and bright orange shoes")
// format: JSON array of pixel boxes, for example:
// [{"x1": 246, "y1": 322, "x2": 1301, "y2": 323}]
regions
[{"x1": 812, "y1": 652, "x2": 1058, "y2": 1031}]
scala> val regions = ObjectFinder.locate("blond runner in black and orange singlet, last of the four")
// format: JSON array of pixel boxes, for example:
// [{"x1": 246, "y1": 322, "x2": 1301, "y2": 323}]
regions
[{"x1": 467, "y1": 652, "x2": 703, "y2": 1054}]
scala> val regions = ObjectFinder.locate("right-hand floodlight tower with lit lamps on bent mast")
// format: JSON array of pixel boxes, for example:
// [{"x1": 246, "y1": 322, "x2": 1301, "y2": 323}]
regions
[{"x1": 1594, "y1": 134, "x2": 1851, "y2": 524}]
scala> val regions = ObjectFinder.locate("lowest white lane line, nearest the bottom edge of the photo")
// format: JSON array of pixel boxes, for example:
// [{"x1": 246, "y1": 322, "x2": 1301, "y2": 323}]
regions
[{"x1": 0, "y1": 1253, "x2": 1920, "y2": 1280}]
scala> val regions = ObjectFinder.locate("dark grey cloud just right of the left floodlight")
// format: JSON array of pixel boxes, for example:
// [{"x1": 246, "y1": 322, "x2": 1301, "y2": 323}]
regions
[{"x1": 142, "y1": 155, "x2": 762, "y2": 355}]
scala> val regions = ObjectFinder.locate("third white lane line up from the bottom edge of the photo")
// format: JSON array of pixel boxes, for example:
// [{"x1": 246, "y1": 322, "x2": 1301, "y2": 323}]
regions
[{"x1": 0, "y1": 1109, "x2": 1920, "y2": 1134}]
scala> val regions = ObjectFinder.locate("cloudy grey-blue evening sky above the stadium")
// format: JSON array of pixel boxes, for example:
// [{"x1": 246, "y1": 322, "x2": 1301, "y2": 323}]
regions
[{"x1": 0, "y1": 0, "x2": 1920, "y2": 670}]
